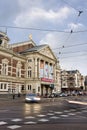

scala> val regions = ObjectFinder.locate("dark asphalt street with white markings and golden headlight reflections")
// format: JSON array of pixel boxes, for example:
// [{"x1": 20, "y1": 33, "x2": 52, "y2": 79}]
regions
[{"x1": 0, "y1": 96, "x2": 87, "y2": 130}]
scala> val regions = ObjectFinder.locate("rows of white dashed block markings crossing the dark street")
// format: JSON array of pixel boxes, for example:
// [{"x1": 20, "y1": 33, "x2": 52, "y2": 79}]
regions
[{"x1": 0, "y1": 109, "x2": 87, "y2": 130}]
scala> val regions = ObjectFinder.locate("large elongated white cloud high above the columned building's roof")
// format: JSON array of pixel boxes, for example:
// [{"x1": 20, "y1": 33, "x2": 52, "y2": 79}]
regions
[{"x1": 14, "y1": 7, "x2": 71, "y2": 27}]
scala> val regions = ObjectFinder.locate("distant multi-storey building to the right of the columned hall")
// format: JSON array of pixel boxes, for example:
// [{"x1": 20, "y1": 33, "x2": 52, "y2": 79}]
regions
[{"x1": 61, "y1": 70, "x2": 85, "y2": 91}]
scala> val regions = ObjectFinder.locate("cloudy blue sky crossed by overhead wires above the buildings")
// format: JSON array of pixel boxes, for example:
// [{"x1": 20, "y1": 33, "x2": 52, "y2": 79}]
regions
[{"x1": 0, "y1": 0, "x2": 87, "y2": 76}]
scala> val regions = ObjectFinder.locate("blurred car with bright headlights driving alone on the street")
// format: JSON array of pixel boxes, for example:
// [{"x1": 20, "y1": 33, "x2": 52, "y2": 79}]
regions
[{"x1": 25, "y1": 93, "x2": 41, "y2": 102}]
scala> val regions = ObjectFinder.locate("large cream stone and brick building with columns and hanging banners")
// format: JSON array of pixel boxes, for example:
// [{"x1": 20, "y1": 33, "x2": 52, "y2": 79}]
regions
[{"x1": 0, "y1": 32, "x2": 61, "y2": 95}]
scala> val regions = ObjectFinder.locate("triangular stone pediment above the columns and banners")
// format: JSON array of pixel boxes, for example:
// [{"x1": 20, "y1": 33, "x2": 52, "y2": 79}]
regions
[{"x1": 39, "y1": 46, "x2": 56, "y2": 59}]
